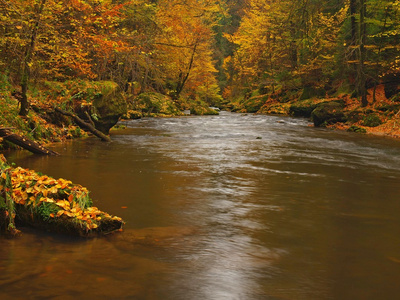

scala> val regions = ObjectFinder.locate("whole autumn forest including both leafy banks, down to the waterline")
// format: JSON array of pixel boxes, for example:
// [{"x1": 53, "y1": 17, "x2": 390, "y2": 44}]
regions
[{"x1": 0, "y1": 0, "x2": 400, "y2": 141}]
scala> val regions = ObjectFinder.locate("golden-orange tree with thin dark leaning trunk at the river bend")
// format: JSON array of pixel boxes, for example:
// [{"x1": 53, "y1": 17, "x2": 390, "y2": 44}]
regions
[{"x1": 155, "y1": 0, "x2": 221, "y2": 99}]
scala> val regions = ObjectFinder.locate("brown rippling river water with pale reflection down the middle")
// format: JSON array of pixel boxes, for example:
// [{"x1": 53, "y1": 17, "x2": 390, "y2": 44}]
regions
[{"x1": 0, "y1": 112, "x2": 400, "y2": 300}]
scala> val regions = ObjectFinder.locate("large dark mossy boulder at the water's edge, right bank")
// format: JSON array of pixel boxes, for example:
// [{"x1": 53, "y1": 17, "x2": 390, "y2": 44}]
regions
[{"x1": 311, "y1": 101, "x2": 346, "y2": 127}]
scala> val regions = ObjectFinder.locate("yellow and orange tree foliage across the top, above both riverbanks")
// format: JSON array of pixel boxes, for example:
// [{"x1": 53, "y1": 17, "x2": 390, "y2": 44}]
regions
[{"x1": 0, "y1": 0, "x2": 400, "y2": 115}]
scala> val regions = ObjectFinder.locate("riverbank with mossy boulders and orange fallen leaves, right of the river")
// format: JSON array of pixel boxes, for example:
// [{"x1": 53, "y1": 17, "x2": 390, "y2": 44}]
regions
[{"x1": 230, "y1": 85, "x2": 400, "y2": 138}]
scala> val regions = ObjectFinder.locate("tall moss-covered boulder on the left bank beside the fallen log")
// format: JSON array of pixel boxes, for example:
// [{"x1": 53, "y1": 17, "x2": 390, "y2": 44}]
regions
[{"x1": 92, "y1": 81, "x2": 128, "y2": 134}]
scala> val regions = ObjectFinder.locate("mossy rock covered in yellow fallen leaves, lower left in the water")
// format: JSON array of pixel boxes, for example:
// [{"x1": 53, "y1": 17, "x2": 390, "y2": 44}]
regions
[{"x1": 0, "y1": 155, "x2": 123, "y2": 236}]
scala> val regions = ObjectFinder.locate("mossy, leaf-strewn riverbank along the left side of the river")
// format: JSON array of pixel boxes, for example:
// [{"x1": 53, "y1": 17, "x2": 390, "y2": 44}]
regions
[{"x1": 0, "y1": 80, "x2": 218, "y2": 150}]
